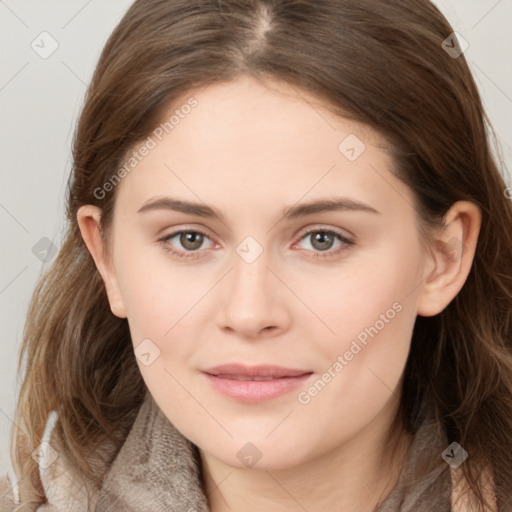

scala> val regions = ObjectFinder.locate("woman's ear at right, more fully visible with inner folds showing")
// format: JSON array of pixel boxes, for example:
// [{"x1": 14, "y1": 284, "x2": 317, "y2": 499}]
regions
[{"x1": 418, "y1": 201, "x2": 482, "y2": 316}]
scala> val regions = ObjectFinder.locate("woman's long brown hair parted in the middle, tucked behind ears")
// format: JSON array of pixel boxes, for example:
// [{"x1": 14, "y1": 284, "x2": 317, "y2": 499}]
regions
[{"x1": 13, "y1": 0, "x2": 512, "y2": 509}]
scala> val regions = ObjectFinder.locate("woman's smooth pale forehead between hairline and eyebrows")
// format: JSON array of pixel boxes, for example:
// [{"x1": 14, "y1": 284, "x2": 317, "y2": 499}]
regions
[{"x1": 111, "y1": 73, "x2": 407, "y2": 220}]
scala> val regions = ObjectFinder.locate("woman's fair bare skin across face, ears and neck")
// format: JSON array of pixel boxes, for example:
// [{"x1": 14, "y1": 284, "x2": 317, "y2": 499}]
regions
[{"x1": 78, "y1": 77, "x2": 481, "y2": 512}]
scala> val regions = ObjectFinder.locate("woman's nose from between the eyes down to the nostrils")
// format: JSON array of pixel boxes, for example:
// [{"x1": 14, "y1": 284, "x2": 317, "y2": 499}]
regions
[{"x1": 218, "y1": 247, "x2": 291, "y2": 340}]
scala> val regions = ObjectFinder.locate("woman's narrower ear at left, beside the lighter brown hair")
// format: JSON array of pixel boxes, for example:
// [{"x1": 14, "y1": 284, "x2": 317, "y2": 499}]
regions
[{"x1": 76, "y1": 204, "x2": 126, "y2": 318}]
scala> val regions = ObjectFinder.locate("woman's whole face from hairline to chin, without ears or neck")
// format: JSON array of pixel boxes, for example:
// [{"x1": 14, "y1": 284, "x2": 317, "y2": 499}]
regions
[{"x1": 95, "y1": 77, "x2": 427, "y2": 468}]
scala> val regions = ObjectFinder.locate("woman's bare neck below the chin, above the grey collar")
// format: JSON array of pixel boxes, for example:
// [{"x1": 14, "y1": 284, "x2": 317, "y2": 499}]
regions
[{"x1": 200, "y1": 398, "x2": 412, "y2": 512}]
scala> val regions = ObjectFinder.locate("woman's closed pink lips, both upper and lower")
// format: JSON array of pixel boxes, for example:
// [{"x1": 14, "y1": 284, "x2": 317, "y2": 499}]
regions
[{"x1": 203, "y1": 364, "x2": 313, "y2": 403}]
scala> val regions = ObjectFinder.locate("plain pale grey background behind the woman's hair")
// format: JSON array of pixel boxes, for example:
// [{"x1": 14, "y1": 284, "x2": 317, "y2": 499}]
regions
[{"x1": 0, "y1": 0, "x2": 512, "y2": 476}]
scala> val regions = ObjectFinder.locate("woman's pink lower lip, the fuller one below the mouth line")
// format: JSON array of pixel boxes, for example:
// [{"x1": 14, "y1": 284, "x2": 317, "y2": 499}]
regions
[{"x1": 205, "y1": 373, "x2": 312, "y2": 403}]
